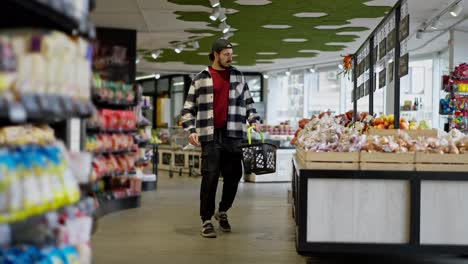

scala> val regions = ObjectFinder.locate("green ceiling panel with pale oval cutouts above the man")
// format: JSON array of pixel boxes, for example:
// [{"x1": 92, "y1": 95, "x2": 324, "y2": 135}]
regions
[{"x1": 139, "y1": 0, "x2": 391, "y2": 66}]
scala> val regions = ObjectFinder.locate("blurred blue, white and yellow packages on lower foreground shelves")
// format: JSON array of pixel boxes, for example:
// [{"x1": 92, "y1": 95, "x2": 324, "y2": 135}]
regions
[{"x1": 0, "y1": 125, "x2": 94, "y2": 263}]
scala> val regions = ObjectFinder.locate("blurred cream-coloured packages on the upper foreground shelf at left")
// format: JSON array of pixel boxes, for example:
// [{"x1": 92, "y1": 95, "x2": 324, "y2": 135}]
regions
[{"x1": 0, "y1": 29, "x2": 94, "y2": 123}]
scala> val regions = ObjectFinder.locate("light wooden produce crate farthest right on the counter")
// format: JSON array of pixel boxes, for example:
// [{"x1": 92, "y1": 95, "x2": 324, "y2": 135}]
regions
[{"x1": 415, "y1": 153, "x2": 468, "y2": 172}]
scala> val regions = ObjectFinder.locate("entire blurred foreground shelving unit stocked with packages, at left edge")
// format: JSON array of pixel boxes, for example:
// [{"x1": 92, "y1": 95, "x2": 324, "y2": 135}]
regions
[{"x1": 0, "y1": 0, "x2": 95, "y2": 263}]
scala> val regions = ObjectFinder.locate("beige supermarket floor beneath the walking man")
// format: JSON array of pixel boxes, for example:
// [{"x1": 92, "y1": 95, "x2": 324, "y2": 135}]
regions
[{"x1": 93, "y1": 172, "x2": 306, "y2": 264}]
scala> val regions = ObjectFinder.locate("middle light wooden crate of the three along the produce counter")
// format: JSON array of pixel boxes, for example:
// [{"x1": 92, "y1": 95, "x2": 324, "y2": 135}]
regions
[{"x1": 359, "y1": 152, "x2": 415, "y2": 171}]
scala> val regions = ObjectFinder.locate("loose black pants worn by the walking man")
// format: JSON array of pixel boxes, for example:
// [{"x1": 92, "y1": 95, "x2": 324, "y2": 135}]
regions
[{"x1": 200, "y1": 129, "x2": 242, "y2": 221}]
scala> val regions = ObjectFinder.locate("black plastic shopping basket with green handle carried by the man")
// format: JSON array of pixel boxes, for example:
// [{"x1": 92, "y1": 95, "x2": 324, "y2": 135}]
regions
[{"x1": 240, "y1": 127, "x2": 276, "y2": 175}]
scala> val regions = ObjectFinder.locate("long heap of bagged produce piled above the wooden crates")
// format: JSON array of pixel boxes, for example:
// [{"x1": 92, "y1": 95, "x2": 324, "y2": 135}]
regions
[{"x1": 293, "y1": 113, "x2": 468, "y2": 154}]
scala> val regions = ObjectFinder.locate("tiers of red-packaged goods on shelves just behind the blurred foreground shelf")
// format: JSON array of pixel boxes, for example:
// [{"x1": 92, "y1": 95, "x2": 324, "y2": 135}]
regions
[{"x1": 85, "y1": 104, "x2": 141, "y2": 214}]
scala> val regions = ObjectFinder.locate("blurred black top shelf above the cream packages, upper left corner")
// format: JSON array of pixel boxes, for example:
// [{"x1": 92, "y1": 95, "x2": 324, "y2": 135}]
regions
[{"x1": 0, "y1": 0, "x2": 95, "y2": 38}]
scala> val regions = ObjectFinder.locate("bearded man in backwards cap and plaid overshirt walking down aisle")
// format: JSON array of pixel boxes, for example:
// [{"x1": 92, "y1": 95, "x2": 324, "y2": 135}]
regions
[{"x1": 181, "y1": 39, "x2": 260, "y2": 238}]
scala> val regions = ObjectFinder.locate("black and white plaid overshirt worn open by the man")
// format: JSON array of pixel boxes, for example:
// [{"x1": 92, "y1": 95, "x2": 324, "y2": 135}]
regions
[{"x1": 181, "y1": 67, "x2": 260, "y2": 142}]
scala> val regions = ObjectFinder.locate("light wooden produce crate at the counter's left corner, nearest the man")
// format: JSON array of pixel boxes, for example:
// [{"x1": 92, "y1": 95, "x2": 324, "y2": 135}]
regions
[{"x1": 296, "y1": 148, "x2": 359, "y2": 170}]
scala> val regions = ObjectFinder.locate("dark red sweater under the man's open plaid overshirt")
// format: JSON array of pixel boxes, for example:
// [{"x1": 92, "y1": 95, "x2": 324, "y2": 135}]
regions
[{"x1": 209, "y1": 67, "x2": 231, "y2": 128}]
